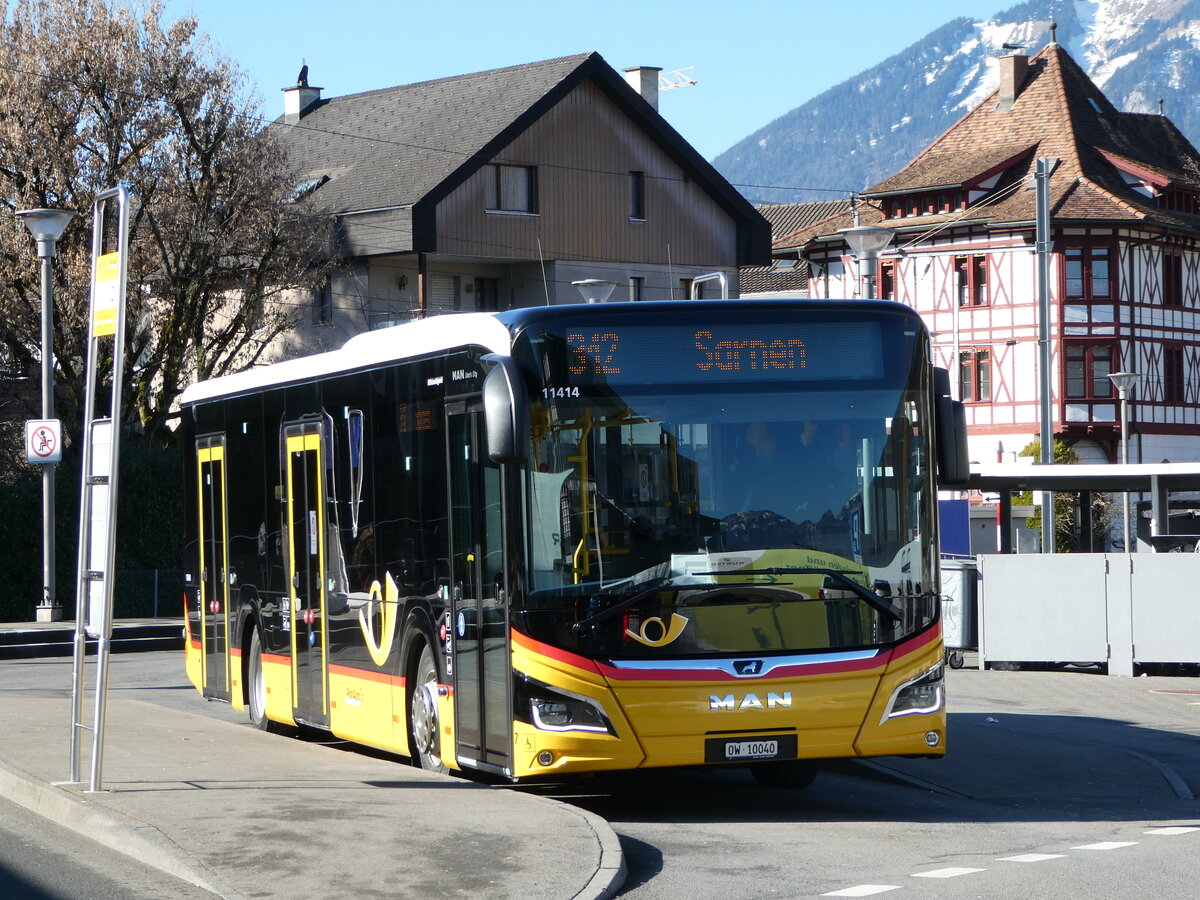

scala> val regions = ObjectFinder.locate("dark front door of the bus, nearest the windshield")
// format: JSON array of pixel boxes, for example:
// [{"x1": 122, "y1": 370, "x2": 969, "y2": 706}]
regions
[{"x1": 446, "y1": 402, "x2": 512, "y2": 770}]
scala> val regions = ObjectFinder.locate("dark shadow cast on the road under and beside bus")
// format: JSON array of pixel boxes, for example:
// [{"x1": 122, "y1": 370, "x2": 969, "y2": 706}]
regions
[{"x1": 523, "y1": 713, "x2": 1200, "y2": 823}]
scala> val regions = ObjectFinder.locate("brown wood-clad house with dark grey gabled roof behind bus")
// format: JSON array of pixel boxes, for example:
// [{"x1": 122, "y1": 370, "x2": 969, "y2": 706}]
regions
[{"x1": 271, "y1": 53, "x2": 770, "y2": 355}]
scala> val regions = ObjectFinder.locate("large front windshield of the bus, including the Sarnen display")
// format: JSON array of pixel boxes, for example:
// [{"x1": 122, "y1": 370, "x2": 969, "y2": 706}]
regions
[{"x1": 518, "y1": 311, "x2": 937, "y2": 659}]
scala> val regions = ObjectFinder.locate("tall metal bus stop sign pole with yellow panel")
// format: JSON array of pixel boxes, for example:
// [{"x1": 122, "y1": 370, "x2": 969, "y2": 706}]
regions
[{"x1": 71, "y1": 187, "x2": 130, "y2": 791}]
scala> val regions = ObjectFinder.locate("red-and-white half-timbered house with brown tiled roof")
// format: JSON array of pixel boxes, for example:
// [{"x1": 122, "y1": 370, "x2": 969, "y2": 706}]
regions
[{"x1": 774, "y1": 43, "x2": 1200, "y2": 487}]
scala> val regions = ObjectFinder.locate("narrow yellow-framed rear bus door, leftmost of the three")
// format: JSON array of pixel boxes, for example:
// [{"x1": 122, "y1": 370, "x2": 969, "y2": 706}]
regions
[{"x1": 196, "y1": 434, "x2": 230, "y2": 700}]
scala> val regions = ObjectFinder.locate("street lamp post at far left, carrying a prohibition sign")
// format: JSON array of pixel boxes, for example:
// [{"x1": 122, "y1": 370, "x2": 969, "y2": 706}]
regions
[{"x1": 17, "y1": 209, "x2": 74, "y2": 622}]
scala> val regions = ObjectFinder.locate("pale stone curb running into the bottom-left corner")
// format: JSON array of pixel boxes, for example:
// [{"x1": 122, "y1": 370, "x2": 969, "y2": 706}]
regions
[{"x1": 0, "y1": 760, "x2": 244, "y2": 900}]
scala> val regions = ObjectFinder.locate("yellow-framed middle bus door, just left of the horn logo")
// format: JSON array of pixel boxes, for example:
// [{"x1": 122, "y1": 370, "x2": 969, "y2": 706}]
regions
[{"x1": 283, "y1": 420, "x2": 329, "y2": 725}]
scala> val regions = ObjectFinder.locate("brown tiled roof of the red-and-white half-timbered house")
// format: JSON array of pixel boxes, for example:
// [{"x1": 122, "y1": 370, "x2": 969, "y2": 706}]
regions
[{"x1": 775, "y1": 43, "x2": 1200, "y2": 252}]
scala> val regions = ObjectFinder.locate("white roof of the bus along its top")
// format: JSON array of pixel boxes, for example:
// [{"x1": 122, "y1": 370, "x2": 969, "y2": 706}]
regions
[{"x1": 180, "y1": 298, "x2": 919, "y2": 406}]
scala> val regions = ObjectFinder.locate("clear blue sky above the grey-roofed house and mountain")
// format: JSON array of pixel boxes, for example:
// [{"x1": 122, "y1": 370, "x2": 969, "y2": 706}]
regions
[{"x1": 166, "y1": 0, "x2": 998, "y2": 160}]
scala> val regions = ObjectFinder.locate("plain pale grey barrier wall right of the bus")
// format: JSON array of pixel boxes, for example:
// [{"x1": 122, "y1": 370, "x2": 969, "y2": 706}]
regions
[{"x1": 978, "y1": 553, "x2": 1200, "y2": 676}]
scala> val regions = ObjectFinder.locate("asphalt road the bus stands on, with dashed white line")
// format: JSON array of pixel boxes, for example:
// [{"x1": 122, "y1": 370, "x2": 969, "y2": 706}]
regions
[{"x1": 0, "y1": 653, "x2": 1200, "y2": 900}]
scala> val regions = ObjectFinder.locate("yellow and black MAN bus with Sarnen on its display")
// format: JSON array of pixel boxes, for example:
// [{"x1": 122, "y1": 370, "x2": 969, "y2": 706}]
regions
[{"x1": 182, "y1": 300, "x2": 966, "y2": 785}]
